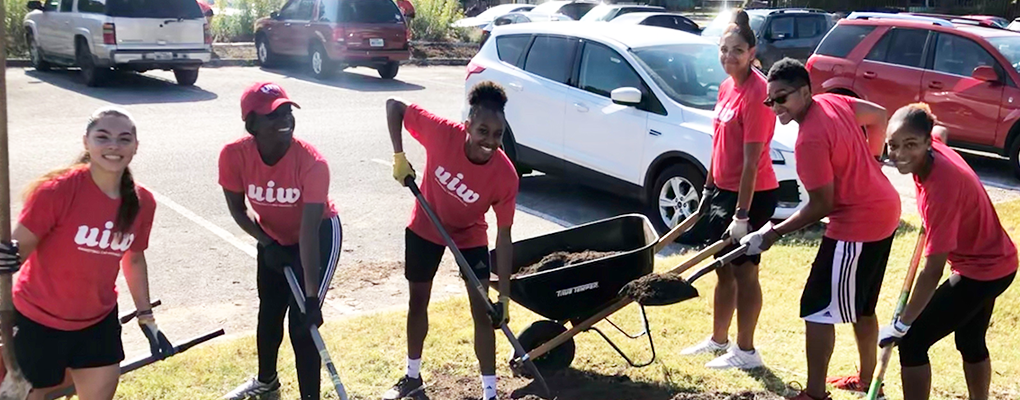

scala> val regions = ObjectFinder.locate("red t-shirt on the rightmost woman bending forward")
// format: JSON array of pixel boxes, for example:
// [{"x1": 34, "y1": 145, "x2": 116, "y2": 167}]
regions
[{"x1": 914, "y1": 140, "x2": 1017, "y2": 281}]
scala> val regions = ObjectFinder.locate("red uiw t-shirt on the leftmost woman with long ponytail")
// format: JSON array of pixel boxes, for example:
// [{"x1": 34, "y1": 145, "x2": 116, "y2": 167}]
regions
[{"x1": 13, "y1": 166, "x2": 156, "y2": 331}]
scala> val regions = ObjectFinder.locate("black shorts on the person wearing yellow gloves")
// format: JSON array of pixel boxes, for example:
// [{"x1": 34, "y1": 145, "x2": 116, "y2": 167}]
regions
[{"x1": 404, "y1": 229, "x2": 491, "y2": 283}]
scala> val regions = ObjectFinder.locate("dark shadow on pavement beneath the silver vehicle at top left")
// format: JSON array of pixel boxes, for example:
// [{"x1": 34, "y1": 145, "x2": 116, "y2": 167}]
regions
[{"x1": 24, "y1": 69, "x2": 217, "y2": 105}]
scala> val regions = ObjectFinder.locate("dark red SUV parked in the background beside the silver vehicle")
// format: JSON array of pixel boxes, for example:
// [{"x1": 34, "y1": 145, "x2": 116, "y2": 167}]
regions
[{"x1": 255, "y1": 0, "x2": 411, "y2": 80}]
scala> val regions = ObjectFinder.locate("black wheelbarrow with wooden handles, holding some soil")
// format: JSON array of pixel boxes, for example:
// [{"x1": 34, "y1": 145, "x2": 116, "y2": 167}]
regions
[{"x1": 492, "y1": 213, "x2": 746, "y2": 377}]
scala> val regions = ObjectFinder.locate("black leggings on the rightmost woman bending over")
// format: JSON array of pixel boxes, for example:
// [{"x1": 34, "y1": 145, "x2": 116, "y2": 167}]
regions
[{"x1": 900, "y1": 272, "x2": 1016, "y2": 367}]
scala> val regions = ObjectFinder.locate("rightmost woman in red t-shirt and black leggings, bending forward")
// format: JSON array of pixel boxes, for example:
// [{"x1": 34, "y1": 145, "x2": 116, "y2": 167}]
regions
[{"x1": 878, "y1": 103, "x2": 1017, "y2": 400}]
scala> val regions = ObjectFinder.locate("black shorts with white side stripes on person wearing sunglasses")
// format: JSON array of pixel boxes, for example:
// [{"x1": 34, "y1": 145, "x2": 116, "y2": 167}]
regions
[{"x1": 801, "y1": 233, "x2": 896, "y2": 324}]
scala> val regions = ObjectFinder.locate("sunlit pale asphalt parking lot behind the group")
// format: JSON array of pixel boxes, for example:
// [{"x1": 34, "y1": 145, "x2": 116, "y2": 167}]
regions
[{"x1": 7, "y1": 66, "x2": 1020, "y2": 358}]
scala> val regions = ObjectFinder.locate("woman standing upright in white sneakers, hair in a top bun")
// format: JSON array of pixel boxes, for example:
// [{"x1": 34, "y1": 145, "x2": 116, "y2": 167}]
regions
[{"x1": 681, "y1": 10, "x2": 779, "y2": 369}]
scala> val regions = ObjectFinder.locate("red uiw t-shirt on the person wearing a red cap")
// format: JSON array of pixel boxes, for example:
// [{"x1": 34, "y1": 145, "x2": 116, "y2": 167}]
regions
[{"x1": 219, "y1": 136, "x2": 337, "y2": 246}]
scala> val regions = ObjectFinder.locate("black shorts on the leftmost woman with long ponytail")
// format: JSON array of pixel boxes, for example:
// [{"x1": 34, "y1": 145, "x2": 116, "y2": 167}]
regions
[{"x1": 14, "y1": 307, "x2": 124, "y2": 389}]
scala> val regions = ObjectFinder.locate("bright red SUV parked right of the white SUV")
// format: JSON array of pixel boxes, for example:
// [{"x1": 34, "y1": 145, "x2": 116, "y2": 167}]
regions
[{"x1": 807, "y1": 12, "x2": 1020, "y2": 177}]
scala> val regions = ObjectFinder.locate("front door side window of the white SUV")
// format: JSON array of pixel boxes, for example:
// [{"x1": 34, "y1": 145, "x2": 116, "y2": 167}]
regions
[{"x1": 577, "y1": 43, "x2": 645, "y2": 97}]
